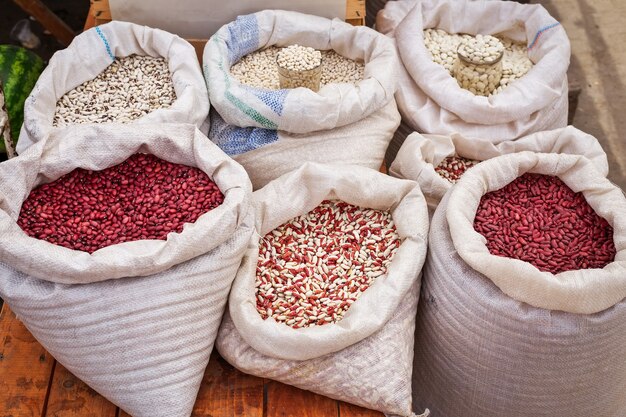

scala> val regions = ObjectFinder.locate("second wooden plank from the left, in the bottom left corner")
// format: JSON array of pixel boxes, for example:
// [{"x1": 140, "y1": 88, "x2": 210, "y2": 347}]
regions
[{"x1": 46, "y1": 363, "x2": 117, "y2": 417}]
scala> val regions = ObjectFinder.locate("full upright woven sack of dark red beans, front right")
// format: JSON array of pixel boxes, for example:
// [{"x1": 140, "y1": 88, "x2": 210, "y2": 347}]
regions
[{"x1": 413, "y1": 152, "x2": 626, "y2": 417}]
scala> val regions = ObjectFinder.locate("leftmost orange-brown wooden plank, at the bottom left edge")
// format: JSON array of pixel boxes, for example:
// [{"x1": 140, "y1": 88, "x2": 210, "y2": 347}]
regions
[{"x1": 0, "y1": 303, "x2": 55, "y2": 417}]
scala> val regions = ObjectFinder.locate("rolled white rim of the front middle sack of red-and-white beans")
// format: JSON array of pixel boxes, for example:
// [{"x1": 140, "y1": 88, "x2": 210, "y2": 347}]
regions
[{"x1": 229, "y1": 163, "x2": 429, "y2": 360}]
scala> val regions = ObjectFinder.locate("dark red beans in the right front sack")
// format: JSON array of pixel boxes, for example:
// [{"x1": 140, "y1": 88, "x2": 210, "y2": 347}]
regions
[{"x1": 474, "y1": 174, "x2": 616, "y2": 274}]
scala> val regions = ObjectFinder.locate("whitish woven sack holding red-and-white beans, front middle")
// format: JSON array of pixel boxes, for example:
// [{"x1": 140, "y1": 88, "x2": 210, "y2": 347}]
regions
[{"x1": 216, "y1": 163, "x2": 428, "y2": 416}]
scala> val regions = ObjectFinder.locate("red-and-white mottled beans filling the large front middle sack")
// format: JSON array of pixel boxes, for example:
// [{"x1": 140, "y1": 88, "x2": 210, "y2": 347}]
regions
[{"x1": 255, "y1": 200, "x2": 401, "y2": 328}]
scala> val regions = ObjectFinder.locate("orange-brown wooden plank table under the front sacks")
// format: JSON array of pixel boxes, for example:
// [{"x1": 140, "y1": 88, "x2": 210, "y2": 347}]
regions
[{"x1": 0, "y1": 303, "x2": 383, "y2": 417}]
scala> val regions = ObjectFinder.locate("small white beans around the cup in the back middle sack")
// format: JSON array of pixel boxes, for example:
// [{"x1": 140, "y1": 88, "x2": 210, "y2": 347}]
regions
[{"x1": 230, "y1": 46, "x2": 365, "y2": 90}]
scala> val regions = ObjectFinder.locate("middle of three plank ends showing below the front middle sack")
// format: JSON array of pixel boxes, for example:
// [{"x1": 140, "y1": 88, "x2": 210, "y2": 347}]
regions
[{"x1": 265, "y1": 381, "x2": 338, "y2": 417}]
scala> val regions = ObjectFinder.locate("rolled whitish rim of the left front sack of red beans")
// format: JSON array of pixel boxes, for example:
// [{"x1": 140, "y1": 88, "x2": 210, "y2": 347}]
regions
[{"x1": 0, "y1": 124, "x2": 252, "y2": 284}]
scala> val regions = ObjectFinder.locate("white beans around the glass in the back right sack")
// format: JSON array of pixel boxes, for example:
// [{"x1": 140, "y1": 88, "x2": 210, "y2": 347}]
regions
[{"x1": 424, "y1": 29, "x2": 534, "y2": 94}]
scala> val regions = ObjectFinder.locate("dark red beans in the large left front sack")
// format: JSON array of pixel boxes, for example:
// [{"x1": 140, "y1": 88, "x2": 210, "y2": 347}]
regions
[{"x1": 17, "y1": 154, "x2": 224, "y2": 253}]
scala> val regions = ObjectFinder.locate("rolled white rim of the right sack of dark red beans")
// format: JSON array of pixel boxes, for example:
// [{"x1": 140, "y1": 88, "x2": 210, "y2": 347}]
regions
[{"x1": 446, "y1": 151, "x2": 626, "y2": 314}]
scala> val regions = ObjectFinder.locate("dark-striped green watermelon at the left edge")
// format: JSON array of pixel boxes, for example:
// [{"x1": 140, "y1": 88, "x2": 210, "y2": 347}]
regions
[{"x1": 0, "y1": 45, "x2": 45, "y2": 152}]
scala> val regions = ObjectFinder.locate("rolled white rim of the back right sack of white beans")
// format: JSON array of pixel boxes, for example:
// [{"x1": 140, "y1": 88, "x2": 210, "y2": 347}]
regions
[{"x1": 395, "y1": 0, "x2": 570, "y2": 125}]
